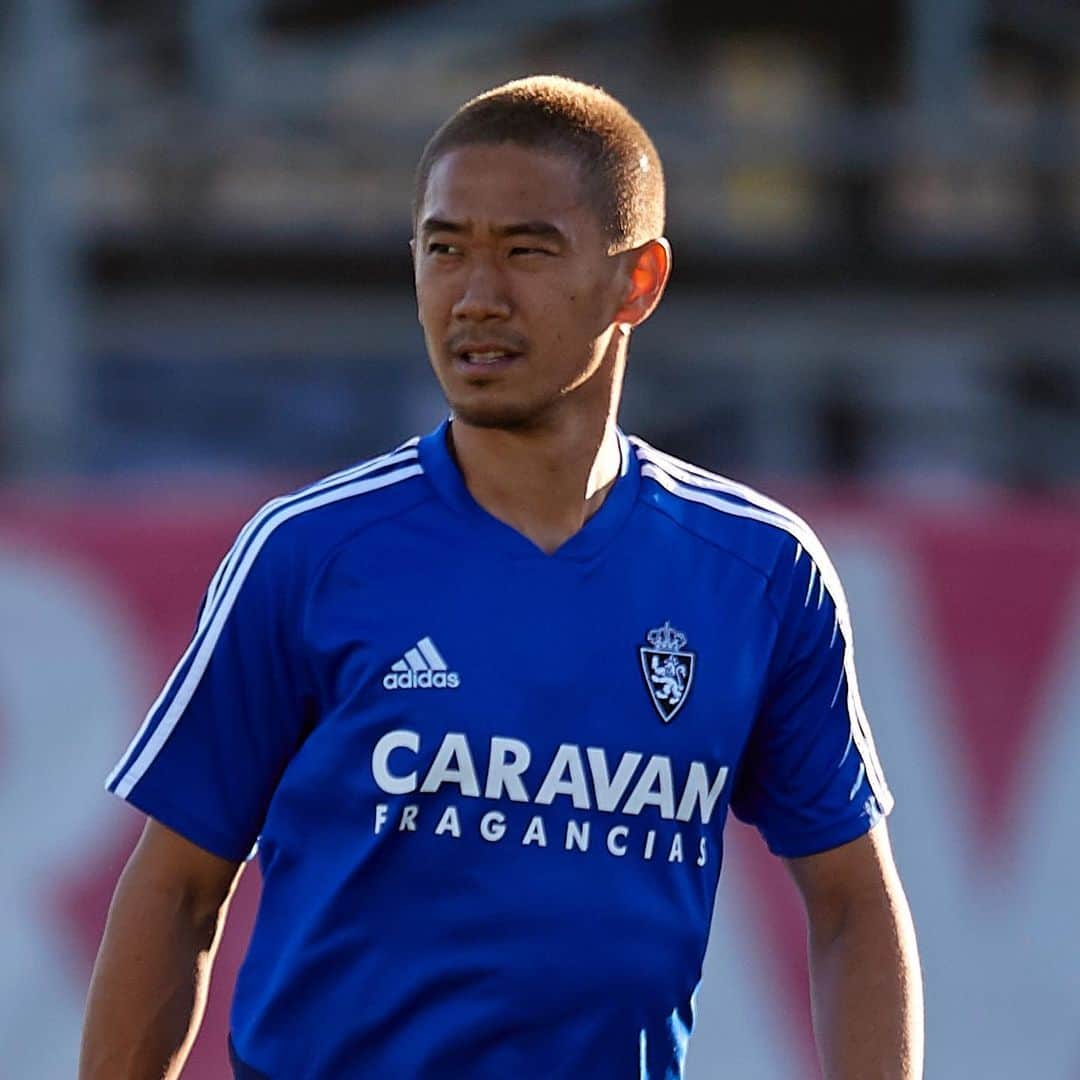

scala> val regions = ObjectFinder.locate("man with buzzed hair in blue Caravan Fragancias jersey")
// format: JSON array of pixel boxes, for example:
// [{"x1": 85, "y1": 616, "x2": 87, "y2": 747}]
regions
[{"x1": 81, "y1": 78, "x2": 922, "y2": 1080}]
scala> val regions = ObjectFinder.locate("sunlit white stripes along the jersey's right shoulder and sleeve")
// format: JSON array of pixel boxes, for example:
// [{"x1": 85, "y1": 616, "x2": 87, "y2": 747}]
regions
[{"x1": 636, "y1": 453, "x2": 893, "y2": 812}]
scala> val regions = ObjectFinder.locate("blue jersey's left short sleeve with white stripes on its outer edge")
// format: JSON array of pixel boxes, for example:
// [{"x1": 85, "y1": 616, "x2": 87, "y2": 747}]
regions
[{"x1": 106, "y1": 517, "x2": 310, "y2": 861}]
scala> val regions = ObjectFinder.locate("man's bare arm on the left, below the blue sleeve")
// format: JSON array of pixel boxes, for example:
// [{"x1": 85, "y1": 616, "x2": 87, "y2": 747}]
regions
[{"x1": 79, "y1": 820, "x2": 241, "y2": 1080}]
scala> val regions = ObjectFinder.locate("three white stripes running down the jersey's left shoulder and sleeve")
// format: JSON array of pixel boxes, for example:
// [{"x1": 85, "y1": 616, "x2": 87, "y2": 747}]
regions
[{"x1": 106, "y1": 454, "x2": 423, "y2": 798}]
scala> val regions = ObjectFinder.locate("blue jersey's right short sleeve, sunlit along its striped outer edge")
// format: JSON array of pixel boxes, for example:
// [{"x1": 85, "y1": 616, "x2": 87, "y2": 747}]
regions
[{"x1": 731, "y1": 535, "x2": 892, "y2": 858}]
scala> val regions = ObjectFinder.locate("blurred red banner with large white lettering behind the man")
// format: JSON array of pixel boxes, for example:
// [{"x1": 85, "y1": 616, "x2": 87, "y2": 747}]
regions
[{"x1": 0, "y1": 491, "x2": 1080, "y2": 1080}]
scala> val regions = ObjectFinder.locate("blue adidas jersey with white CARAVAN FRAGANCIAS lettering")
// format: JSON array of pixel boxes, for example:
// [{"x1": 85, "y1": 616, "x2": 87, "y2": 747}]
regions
[{"x1": 108, "y1": 424, "x2": 891, "y2": 1080}]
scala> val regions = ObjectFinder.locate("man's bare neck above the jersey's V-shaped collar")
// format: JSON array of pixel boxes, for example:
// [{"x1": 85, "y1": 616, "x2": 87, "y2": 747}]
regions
[{"x1": 449, "y1": 411, "x2": 621, "y2": 554}]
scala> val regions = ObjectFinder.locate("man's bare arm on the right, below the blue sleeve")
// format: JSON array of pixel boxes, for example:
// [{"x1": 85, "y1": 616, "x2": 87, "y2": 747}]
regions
[{"x1": 787, "y1": 822, "x2": 923, "y2": 1080}]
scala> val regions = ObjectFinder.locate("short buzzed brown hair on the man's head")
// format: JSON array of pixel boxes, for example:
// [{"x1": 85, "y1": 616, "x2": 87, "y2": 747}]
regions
[{"x1": 413, "y1": 76, "x2": 664, "y2": 251}]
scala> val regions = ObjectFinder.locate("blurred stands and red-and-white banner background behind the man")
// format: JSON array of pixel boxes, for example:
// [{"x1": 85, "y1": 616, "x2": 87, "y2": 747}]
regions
[{"x1": 0, "y1": 0, "x2": 1080, "y2": 1080}]
